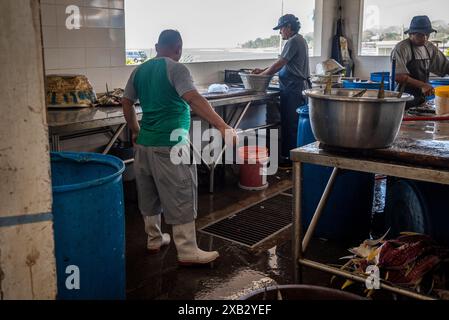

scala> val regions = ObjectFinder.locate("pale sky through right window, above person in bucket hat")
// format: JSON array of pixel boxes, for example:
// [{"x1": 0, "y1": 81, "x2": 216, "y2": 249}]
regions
[{"x1": 364, "y1": 0, "x2": 449, "y2": 29}]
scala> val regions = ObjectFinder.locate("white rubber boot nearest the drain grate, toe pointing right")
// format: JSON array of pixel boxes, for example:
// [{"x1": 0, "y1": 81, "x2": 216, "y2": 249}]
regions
[{"x1": 173, "y1": 221, "x2": 220, "y2": 266}]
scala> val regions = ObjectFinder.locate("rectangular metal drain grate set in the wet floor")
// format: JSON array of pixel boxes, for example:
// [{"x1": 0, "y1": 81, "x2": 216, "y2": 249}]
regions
[{"x1": 200, "y1": 194, "x2": 292, "y2": 248}]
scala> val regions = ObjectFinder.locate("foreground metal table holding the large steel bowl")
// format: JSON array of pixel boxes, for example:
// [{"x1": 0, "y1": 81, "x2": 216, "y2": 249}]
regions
[{"x1": 291, "y1": 122, "x2": 449, "y2": 299}]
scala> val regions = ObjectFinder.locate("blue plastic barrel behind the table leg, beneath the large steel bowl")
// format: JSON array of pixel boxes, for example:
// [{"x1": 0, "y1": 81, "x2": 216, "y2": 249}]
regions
[{"x1": 298, "y1": 106, "x2": 374, "y2": 240}]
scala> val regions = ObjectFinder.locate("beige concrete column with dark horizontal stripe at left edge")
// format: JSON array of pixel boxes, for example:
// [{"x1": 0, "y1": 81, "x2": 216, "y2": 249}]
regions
[{"x1": 0, "y1": 0, "x2": 56, "y2": 299}]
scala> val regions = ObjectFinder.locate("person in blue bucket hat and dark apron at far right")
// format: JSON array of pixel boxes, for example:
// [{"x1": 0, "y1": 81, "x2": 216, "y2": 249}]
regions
[{"x1": 391, "y1": 16, "x2": 449, "y2": 108}]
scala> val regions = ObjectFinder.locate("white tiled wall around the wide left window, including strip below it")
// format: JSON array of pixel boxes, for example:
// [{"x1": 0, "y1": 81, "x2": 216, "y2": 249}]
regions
[{"x1": 41, "y1": 0, "x2": 336, "y2": 93}]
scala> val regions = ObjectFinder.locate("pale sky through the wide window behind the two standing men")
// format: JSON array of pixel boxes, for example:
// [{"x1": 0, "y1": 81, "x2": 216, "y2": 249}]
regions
[{"x1": 125, "y1": 0, "x2": 315, "y2": 49}]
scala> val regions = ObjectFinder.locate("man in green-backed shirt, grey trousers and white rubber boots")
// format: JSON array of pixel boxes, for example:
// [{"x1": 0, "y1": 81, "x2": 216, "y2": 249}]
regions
[{"x1": 123, "y1": 30, "x2": 237, "y2": 265}]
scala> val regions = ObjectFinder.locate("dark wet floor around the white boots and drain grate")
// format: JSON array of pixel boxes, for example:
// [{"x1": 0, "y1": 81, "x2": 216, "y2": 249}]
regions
[{"x1": 125, "y1": 171, "x2": 390, "y2": 300}]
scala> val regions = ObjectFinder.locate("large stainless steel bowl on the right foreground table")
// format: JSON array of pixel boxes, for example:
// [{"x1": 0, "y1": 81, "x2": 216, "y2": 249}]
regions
[{"x1": 304, "y1": 89, "x2": 413, "y2": 149}]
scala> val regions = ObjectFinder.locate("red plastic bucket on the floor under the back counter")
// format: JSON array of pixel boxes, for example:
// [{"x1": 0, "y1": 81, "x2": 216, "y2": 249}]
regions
[{"x1": 238, "y1": 147, "x2": 269, "y2": 191}]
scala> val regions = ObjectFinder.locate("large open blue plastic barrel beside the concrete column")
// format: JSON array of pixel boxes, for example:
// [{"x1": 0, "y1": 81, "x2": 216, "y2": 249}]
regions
[{"x1": 51, "y1": 152, "x2": 126, "y2": 300}]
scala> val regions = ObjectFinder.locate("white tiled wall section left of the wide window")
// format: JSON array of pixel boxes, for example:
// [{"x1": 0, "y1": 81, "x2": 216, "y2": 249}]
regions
[{"x1": 41, "y1": 0, "x2": 132, "y2": 92}]
